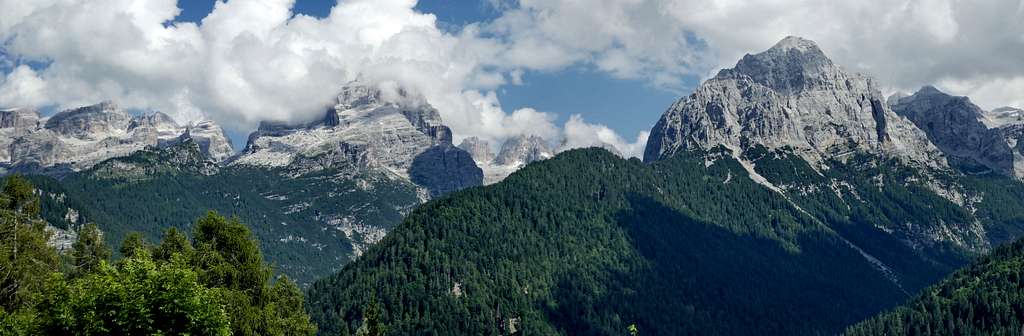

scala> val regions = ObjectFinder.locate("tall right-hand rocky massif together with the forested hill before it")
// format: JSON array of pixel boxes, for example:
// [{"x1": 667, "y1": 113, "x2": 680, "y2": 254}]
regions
[{"x1": 307, "y1": 37, "x2": 1024, "y2": 335}]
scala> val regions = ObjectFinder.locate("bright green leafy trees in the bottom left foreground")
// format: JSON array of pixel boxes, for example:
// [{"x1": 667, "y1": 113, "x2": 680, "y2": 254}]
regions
[{"x1": 0, "y1": 176, "x2": 315, "y2": 335}]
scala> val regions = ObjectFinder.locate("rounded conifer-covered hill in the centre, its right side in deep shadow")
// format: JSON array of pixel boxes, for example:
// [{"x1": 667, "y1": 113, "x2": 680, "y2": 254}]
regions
[{"x1": 307, "y1": 149, "x2": 952, "y2": 335}]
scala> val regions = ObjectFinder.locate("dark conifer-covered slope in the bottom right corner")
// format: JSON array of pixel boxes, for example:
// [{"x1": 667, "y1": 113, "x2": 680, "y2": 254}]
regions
[{"x1": 846, "y1": 237, "x2": 1024, "y2": 336}]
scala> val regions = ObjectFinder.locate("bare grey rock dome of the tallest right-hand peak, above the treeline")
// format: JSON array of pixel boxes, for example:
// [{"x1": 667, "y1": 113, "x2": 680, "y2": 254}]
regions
[{"x1": 644, "y1": 37, "x2": 944, "y2": 166}]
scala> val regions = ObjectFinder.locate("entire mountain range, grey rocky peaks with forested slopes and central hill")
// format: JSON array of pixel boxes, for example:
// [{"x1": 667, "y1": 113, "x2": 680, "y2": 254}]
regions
[{"x1": 0, "y1": 37, "x2": 1024, "y2": 335}]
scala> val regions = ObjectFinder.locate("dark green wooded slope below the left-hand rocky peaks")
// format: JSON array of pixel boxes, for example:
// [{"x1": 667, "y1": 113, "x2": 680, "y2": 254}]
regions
[{"x1": 33, "y1": 140, "x2": 420, "y2": 284}]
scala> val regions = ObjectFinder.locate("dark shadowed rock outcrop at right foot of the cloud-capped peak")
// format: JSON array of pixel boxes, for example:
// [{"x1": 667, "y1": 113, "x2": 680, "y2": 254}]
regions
[{"x1": 409, "y1": 144, "x2": 483, "y2": 197}]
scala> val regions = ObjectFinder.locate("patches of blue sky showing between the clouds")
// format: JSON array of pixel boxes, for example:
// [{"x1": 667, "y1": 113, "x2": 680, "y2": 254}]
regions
[{"x1": 177, "y1": 0, "x2": 693, "y2": 146}]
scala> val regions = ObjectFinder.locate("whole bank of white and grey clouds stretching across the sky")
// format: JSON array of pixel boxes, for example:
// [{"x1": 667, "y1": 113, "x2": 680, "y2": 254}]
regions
[{"x1": 0, "y1": 0, "x2": 1024, "y2": 159}]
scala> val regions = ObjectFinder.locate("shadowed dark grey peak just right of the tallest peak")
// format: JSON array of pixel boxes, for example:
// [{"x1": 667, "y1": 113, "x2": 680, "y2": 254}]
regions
[{"x1": 893, "y1": 86, "x2": 1014, "y2": 175}]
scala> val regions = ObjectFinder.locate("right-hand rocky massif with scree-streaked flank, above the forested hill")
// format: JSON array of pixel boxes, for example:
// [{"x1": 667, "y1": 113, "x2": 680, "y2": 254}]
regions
[{"x1": 644, "y1": 37, "x2": 1017, "y2": 271}]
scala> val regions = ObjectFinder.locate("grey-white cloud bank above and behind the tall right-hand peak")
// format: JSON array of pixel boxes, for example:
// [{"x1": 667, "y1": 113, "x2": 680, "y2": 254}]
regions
[{"x1": 483, "y1": 0, "x2": 1024, "y2": 107}]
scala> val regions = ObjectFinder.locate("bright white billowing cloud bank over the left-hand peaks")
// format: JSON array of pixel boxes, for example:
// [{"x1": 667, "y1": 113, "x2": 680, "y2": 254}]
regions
[{"x1": 0, "y1": 0, "x2": 536, "y2": 135}]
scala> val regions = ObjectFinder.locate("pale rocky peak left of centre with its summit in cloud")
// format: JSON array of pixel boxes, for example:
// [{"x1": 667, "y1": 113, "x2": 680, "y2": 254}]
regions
[{"x1": 231, "y1": 82, "x2": 480, "y2": 195}]
